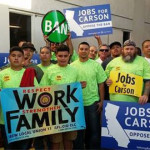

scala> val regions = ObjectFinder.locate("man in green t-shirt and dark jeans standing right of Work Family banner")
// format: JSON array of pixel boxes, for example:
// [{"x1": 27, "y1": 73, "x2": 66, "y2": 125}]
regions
[{"x1": 71, "y1": 42, "x2": 106, "y2": 149}]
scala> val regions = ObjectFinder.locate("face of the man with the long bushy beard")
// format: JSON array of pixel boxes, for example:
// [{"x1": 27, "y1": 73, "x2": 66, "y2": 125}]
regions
[{"x1": 122, "y1": 46, "x2": 137, "y2": 62}]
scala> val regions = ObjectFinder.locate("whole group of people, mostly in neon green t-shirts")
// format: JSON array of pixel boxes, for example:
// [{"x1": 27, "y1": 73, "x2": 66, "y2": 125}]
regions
[{"x1": 0, "y1": 35, "x2": 150, "y2": 149}]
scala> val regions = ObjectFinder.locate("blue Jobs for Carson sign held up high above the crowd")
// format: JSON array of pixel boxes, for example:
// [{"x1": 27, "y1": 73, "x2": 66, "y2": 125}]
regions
[{"x1": 64, "y1": 4, "x2": 112, "y2": 38}]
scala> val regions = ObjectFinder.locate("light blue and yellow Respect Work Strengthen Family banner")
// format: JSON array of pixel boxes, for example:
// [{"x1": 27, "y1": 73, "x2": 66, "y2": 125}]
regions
[{"x1": 1, "y1": 82, "x2": 85, "y2": 143}]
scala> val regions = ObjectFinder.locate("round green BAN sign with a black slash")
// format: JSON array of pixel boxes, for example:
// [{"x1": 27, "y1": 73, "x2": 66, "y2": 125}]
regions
[{"x1": 42, "y1": 10, "x2": 68, "y2": 43}]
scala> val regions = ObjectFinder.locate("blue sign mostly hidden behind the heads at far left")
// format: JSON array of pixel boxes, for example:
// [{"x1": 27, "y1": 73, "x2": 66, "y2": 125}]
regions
[{"x1": 0, "y1": 53, "x2": 40, "y2": 67}]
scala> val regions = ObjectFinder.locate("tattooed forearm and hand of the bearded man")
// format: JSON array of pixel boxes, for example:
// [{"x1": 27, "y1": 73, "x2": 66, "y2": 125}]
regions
[{"x1": 138, "y1": 81, "x2": 150, "y2": 104}]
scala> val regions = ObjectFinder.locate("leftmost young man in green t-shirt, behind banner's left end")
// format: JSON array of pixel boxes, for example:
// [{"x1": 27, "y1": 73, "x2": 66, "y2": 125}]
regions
[{"x1": 0, "y1": 46, "x2": 38, "y2": 149}]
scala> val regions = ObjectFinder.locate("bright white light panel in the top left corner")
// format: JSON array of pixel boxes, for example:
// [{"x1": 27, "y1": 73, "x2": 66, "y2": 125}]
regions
[{"x1": 0, "y1": 0, "x2": 31, "y2": 9}]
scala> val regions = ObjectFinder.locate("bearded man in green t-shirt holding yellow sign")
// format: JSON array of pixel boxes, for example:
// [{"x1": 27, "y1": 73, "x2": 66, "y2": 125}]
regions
[{"x1": 105, "y1": 40, "x2": 150, "y2": 104}]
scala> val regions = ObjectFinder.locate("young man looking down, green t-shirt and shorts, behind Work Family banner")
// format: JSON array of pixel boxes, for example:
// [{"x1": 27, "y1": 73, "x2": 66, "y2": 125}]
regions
[{"x1": 41, "y1": 44, "x2": 78, "y2": 150}]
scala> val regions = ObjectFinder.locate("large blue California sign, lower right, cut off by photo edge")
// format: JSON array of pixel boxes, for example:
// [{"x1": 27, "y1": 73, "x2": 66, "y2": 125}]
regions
[{"x1": 101, "y1": 101, "x2": 150, "y2": 149}]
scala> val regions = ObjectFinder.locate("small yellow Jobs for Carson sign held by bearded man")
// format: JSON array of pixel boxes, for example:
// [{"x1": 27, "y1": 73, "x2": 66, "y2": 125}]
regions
[{"x1": 109, "y1": 71, "x2": 143, "y2": 97}]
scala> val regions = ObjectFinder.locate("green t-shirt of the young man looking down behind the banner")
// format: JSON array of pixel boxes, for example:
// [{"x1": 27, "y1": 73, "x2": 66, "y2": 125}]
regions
[{"x1": 41, "y1": 64, "x2": 77, "y2": 85}]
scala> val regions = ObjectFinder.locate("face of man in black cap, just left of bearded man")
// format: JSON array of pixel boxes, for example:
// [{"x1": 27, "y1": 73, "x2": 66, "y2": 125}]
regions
[{"x1": 111, "y1": 45, "x2": 122, "y2": 58}]
